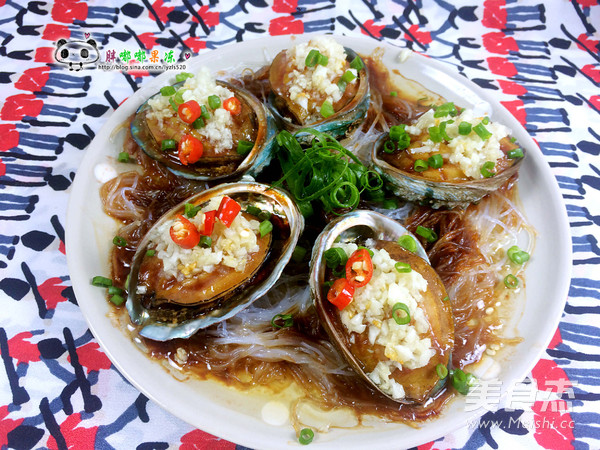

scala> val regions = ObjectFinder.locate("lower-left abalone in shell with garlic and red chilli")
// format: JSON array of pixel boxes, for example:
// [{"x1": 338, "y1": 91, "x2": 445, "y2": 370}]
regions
[{"x1": 127, "y1": 182, "x2": 304, "y2": 340}]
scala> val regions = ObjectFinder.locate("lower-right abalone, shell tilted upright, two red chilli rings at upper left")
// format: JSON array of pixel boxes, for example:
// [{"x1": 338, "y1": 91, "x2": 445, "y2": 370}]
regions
[{"x1": 310, "y1": 211, "x2": 454, "y2": 403}]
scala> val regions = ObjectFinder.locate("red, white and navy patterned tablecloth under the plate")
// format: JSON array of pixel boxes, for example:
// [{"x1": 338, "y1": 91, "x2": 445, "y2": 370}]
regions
[{"x1": 0, "y1": 0, "x2": 600, "y2": 449}]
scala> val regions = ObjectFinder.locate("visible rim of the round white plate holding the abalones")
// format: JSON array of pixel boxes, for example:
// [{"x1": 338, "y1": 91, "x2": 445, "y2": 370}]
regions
[{"x1": 66, "y1": 36, "x2": 571, "y2": 449}]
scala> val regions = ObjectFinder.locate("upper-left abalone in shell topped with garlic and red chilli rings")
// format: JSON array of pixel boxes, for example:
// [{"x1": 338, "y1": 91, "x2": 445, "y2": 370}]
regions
[{"x1": 131, "y1": 69, "x2": 276, "y2": 181}]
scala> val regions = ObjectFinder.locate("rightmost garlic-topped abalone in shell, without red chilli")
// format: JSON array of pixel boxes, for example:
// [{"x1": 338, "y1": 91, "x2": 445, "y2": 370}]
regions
[{"x1": 371, "y1": 103, "x2": 525, "y2": 208}]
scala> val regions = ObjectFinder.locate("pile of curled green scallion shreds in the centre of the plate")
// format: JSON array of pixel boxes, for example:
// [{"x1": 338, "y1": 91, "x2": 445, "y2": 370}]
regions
[{"x1": 274, "y1": 128, "x2": 384, "y2": 217}]
